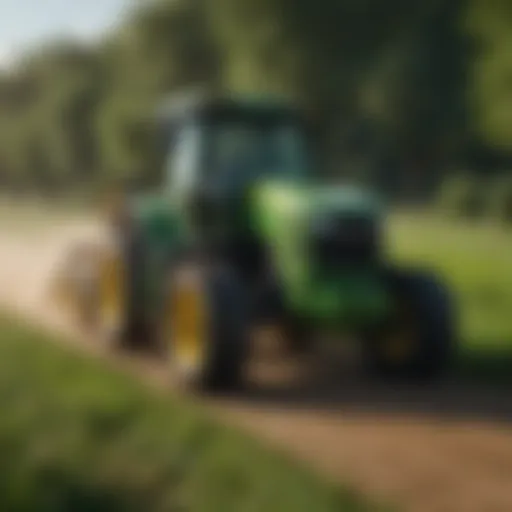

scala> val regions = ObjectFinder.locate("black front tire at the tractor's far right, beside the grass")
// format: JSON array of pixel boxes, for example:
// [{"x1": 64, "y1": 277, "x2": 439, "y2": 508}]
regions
[{"x1": 365, "y1": 270, "x2": 455, "y2": 380}]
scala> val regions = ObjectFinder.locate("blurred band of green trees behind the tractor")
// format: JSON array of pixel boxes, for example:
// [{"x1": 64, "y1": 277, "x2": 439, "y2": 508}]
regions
[{"x1": 0, "y1": 0, "x2": 512, "y2": 194}]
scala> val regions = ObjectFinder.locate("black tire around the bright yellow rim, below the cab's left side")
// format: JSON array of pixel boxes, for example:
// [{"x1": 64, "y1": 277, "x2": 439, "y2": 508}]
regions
[{"x1": 165, "y1": 264, "x2": 250, "y2": 393}]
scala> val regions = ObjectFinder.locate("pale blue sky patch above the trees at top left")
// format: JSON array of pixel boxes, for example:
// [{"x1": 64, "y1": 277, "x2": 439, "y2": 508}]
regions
[{"x1": 0, "y1": 0, "x2": 134, "y2": 67}]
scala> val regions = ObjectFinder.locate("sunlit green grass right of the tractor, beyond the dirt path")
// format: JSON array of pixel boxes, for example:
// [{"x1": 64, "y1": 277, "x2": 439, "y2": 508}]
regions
[{"x1": 388, "y1": 214, "x2": 512, "y2": 382}]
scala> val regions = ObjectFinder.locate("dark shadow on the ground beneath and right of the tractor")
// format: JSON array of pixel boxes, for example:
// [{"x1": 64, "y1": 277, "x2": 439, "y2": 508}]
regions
[{"x1": 227, "y1": 343, "x2": 512, "y2": 424}]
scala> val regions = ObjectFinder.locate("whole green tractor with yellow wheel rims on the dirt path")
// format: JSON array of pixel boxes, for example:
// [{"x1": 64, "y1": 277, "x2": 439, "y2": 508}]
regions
[{"x1": 54, "y1": 93, "x2": 453, "y2": 391}]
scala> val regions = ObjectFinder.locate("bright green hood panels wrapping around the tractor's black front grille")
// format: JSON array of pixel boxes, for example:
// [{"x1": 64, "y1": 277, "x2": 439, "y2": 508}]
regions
[{"x1": 252, "y1": 182, "x2": 387, "y2": 321}]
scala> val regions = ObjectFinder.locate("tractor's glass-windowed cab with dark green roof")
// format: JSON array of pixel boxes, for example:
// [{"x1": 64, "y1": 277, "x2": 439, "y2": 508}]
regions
[{"x1": 160, "y1": 98, "x2": 308, "y2": 207}]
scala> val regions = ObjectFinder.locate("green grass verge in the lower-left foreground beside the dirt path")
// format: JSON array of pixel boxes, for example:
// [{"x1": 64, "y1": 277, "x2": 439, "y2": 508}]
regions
[{"x1": 0, "y1": 318, "x2": 376, "y2": 512}]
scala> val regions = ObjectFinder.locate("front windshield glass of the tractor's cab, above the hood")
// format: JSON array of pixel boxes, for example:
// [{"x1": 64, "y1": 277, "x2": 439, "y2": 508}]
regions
[{"x1": 204, "y1": 122, "x2": 306, "y2": 188}]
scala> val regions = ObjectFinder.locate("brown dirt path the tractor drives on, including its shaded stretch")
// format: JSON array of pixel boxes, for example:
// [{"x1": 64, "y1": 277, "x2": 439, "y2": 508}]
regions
[{"x1": 0, "y1": 217, "x2": 512, "y2": 512}]
